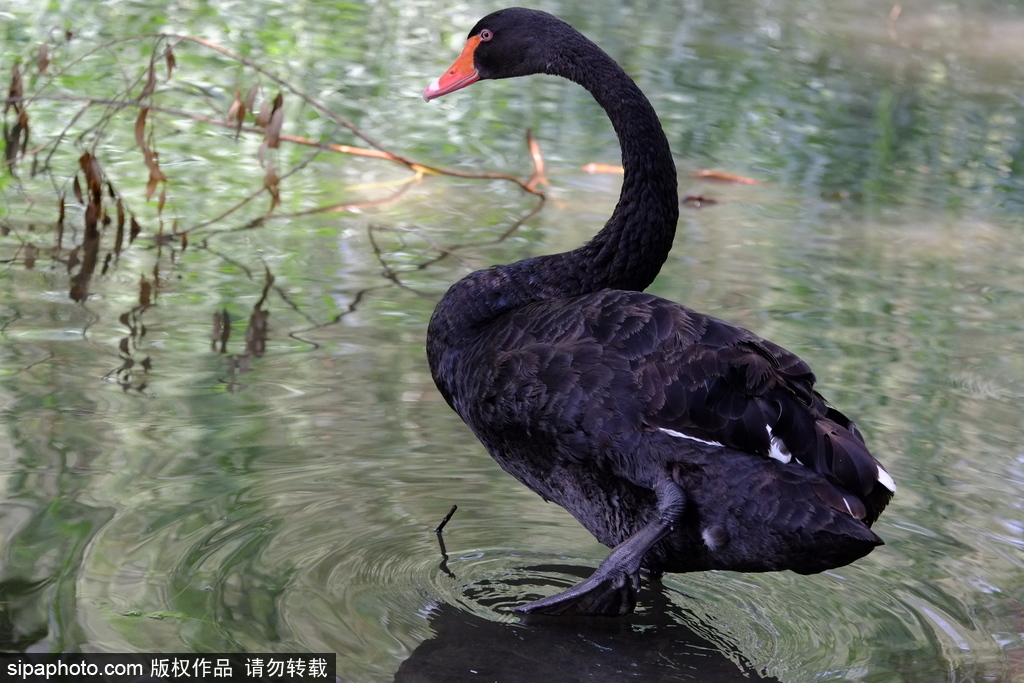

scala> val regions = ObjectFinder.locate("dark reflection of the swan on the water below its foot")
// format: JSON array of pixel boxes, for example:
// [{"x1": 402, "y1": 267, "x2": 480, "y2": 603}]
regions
[{"x1": 394, "y1": 564, "x2": 778, "y2": 683}]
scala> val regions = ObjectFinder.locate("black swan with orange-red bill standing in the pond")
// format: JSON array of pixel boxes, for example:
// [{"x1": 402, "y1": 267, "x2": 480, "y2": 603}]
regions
[{"x1": 423, "y1": 8, "x2": 896, "y2": 615}]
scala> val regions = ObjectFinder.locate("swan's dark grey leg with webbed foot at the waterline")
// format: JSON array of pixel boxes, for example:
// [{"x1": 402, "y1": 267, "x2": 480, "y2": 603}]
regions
[{"x1": 514, "y1": 479, "x2": 686, "y2": 616}]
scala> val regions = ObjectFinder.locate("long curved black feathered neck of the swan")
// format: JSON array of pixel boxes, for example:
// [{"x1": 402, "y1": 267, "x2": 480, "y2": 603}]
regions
[{"x1": 428, "y1": 34, "x2": 679, "y2": 365}]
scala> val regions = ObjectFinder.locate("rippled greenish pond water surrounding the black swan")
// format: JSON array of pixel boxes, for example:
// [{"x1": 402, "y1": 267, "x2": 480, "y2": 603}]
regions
[{"x1": 0, "y1": 0, "x2": 1024, "y2": 683}]
